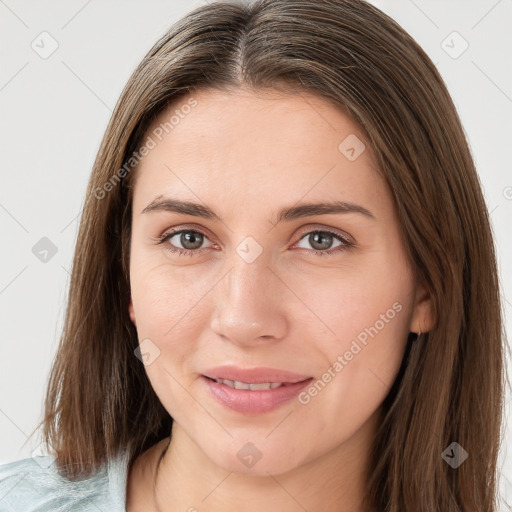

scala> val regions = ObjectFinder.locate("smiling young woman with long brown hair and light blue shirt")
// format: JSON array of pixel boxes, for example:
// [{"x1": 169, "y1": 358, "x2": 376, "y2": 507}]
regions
[{"x1": 0, "y1": 0, "x2": 503, "y2": 512}]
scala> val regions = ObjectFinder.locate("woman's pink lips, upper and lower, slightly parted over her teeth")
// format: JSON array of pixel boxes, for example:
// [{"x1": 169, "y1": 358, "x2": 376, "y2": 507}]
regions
[{"x1": 200, "y1": 366, "x2": 313, "y2": 414}]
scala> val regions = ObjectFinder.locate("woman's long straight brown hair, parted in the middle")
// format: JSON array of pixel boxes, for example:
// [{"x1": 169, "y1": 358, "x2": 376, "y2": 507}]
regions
[{"x1": 37, "y1": 0, "x2": 505, "y2": 512}]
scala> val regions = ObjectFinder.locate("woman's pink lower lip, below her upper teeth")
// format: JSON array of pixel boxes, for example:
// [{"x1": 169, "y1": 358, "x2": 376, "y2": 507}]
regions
[{"x1": 201, "y1": 375, "x2": 313, "y2": 414}]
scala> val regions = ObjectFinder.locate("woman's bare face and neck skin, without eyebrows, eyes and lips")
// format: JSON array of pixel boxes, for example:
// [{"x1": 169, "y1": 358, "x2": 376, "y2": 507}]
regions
[{"x1": 127, "y1": 86, "x2": 432, "y2": 512}]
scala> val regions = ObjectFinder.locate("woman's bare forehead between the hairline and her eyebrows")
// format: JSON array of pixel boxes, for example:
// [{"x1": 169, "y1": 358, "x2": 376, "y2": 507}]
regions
[{"x1": 134, "y1": 85, "x2": 385, "y2": 216}]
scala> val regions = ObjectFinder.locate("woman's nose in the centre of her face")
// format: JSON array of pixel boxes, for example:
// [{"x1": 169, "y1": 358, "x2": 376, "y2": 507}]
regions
[{"x1": 211, "y1": 257, "x2": 290, "y2": 346}]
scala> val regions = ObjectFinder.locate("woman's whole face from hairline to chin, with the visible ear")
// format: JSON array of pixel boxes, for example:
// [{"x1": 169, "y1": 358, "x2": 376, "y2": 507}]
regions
[{"x1": 130, "y1": 90, "x2": 429, "y2": 475}]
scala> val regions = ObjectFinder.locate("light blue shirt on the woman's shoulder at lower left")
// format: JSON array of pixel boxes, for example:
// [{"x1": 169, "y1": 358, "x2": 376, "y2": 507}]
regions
[{"x1": 0, "y1": 451, "x2": 129, "y2": 512}]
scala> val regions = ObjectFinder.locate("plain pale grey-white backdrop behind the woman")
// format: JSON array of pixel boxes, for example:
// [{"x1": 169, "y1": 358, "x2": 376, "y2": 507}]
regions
[{"x1": 0, "y1": 0, "x2": 512, "y2": 510}]
